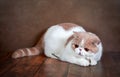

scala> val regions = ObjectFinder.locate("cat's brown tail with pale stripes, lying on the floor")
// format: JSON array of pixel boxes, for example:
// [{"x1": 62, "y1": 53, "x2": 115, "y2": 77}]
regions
[{"x1": 12, "y1": 34, "x2": 44, "y2": 58}]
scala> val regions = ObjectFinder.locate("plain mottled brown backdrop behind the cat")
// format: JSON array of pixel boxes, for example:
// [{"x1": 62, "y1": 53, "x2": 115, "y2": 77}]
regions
[{"x1": 0, "y1": 0, "x2": 120, "y2": 53}]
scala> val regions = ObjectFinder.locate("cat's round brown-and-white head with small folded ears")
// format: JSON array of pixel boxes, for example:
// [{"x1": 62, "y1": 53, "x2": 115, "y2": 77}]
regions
[{"x1": 71, "y1": 32, "x2": 101, "y2": 56}]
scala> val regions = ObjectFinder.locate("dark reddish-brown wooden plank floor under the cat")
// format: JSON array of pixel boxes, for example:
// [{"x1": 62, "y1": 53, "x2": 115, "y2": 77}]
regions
[{"x1": 0, "y1": 52, "x2": 120, "y2": 77}]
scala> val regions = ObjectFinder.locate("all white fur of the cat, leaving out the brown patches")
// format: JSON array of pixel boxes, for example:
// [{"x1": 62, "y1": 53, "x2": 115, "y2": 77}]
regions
[{"x1": 43, "y1": 25, "x2": 102, "y2": 66}]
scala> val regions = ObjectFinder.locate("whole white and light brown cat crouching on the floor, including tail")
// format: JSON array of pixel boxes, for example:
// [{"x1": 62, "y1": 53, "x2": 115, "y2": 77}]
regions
[{"x1": 12, "y1": 23, "x2": 103, "y2": 66}]
